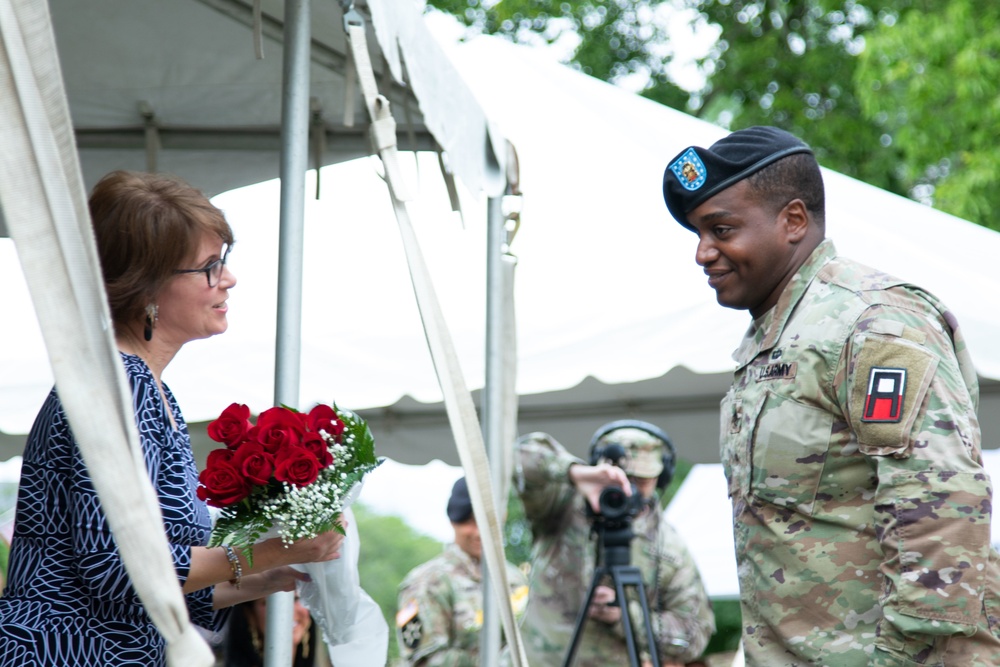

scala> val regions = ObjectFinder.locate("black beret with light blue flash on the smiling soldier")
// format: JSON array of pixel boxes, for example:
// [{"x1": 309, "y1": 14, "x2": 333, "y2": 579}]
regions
[{"x1": 663, "y1": 126, "x2": 812, "y2": 230}]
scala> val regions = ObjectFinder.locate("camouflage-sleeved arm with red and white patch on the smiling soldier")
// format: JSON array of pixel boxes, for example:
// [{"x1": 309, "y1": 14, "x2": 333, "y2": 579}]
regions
[{"x1": 835, "y1": 307, "x2": 992, "y2": 664}]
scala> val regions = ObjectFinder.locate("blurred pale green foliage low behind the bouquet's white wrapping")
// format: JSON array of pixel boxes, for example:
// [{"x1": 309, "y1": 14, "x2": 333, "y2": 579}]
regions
[{"x1": 352, "y1": 504, "x2": 443, "y2": 664}]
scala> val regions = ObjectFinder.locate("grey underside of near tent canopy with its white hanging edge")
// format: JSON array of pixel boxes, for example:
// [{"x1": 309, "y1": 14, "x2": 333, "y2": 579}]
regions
[{"x1": 41, "y1": 0, "x2": 502, "y2": 196}]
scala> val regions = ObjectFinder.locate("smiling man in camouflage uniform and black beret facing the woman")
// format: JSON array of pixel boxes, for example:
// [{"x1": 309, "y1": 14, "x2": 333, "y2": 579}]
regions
[{"x1": 664, "y1": 127, "x2": 1000, "y2": 667}]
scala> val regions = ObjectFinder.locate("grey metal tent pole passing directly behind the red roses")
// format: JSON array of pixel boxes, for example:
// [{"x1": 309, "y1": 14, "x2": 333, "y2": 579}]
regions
[{"x1": 264, "y1": 0, "x2": 310, "y2": 667}]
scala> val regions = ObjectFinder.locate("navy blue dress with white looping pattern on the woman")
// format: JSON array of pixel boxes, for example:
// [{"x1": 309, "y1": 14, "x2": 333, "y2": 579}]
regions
[{"x1": 0, "y1": 354, "x2": 228, "y2": 667}]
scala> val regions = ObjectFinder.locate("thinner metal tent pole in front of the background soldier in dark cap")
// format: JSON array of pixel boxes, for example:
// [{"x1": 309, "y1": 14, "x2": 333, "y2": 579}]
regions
[{"x1": 479, "y1": 197, "x2": 507, "y2": 667}]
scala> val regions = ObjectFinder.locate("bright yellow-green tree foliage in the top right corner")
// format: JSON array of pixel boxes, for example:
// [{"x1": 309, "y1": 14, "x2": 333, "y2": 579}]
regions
[{"x1": 855, "y1": 0, "x2": 1000, "y2": 230}]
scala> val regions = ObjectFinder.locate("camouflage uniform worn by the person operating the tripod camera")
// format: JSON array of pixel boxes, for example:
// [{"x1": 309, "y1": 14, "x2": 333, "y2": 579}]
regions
[{"x1": 515, "y1": 433, "x2": 715, "y2": 667}]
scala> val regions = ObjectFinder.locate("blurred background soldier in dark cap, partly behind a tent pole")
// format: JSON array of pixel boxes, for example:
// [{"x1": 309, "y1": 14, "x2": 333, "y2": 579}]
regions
[{"x1": 396, "y1": 477, "x2": 528, "y2": 667}]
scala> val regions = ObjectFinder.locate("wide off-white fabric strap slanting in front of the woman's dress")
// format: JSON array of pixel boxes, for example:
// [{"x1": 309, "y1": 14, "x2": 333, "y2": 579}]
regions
[{"x1": 0, "y1": 0, "x2": 213, "y2": 667}]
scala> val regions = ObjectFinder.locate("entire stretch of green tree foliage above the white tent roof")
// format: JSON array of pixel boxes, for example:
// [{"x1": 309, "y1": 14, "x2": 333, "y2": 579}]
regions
[{"x1": 430, "y1": 0, "x2": 1000, "y2": 224}]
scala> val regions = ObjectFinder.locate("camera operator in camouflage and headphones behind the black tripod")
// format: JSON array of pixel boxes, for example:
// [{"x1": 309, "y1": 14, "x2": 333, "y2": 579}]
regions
[{"x1": 514, "y1": 420, "x2": 715, "y2": 667}]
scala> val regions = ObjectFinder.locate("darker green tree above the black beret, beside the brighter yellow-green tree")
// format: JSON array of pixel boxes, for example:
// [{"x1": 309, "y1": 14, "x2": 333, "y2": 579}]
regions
[{"x1": 688, "y1": 0, "x2": 906, "y2": 194}]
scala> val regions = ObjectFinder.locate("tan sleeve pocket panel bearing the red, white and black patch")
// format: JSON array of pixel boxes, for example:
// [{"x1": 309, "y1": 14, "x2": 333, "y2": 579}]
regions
[{"x1": 850, "y1": 334, "x2": 938, "y2": 458}]
